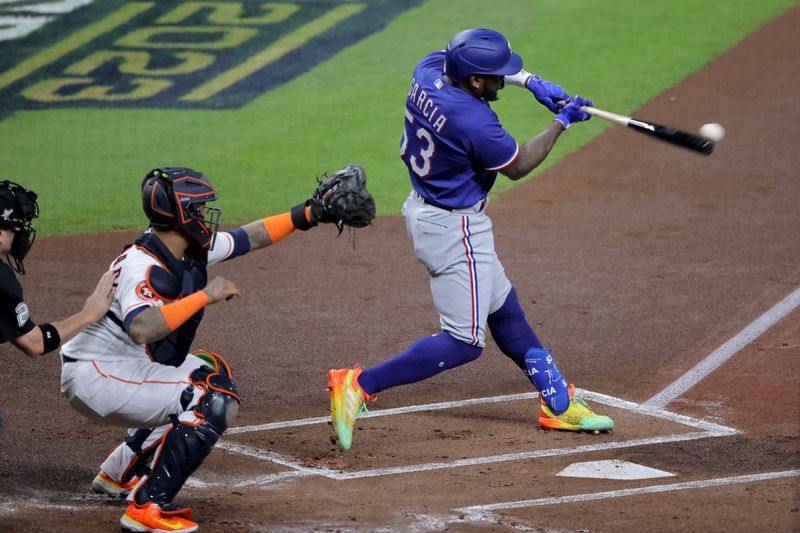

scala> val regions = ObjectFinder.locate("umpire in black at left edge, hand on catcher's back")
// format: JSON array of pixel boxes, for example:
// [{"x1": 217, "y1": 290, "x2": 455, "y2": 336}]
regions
[{"x1": 0, "y1": 180, "x2": 114, "y2": 430}]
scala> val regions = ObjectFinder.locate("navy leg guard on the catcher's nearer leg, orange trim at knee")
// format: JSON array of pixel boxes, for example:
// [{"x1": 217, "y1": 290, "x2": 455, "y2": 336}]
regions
[{"x1": 134, "y1": 352, "x2": 240, "y2": 508}]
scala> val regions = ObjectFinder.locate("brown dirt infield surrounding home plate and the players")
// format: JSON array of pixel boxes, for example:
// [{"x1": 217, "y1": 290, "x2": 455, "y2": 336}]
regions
[{"x1": 0, "y1": 7, "x2": 800, "y2": 533}]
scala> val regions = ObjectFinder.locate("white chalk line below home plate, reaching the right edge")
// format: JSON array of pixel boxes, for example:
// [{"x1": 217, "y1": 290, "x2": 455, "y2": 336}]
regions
[{"x1": 453, "y1": 470, "x2": 800, "y2": 519}]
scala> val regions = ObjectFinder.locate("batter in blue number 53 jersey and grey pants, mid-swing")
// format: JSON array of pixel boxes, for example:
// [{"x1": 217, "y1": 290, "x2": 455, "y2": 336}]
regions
[{"x1": 328, "y1": 29, "x2": 613, "y2": 451}]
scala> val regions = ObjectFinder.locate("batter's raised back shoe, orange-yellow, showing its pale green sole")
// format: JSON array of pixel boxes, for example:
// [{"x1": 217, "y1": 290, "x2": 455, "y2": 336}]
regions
[{"x1": 328, "y1": 365, "x2": 378, "y2": 452}]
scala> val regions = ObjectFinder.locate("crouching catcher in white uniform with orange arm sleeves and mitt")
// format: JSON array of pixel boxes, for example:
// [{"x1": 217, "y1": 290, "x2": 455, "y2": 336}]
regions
[{"x1": 61, "y1": 165, "x2": 375, "y2": 532}]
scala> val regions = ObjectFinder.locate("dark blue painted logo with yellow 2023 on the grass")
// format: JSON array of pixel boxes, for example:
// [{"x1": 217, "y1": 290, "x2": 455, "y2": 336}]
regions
[{"x1": 0, "y1": 0, "x2": 422, "y2": 119}]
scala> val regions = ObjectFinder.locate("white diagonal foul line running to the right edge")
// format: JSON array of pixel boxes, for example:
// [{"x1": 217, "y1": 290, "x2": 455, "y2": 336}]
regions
[{"x1": 644, "y1": 288, "x2": 800, "y2": 407}]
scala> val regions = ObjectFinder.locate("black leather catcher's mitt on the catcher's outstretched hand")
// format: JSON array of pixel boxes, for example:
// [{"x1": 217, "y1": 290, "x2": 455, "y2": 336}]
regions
[{"x1": 309, "y1": 165, "x2": 375, "y2": 229}]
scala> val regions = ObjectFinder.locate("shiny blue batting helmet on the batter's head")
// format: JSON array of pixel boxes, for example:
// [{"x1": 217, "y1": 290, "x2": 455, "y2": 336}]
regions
[{"x1": 444, "y1": 28, "x2": 522, "y2": 81}]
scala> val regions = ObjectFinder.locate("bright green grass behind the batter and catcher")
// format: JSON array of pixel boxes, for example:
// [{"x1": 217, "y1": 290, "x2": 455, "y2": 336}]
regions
[{"x1": 0, "y1": 0, "x2": 796, "y2": 235}]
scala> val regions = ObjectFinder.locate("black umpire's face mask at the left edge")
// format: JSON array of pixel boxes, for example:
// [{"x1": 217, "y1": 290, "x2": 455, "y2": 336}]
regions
[{"x1": 0, "y1": 180, "x2": 39, "y2": 274}]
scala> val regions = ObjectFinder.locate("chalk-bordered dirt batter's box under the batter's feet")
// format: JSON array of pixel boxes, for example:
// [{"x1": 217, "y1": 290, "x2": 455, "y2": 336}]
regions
[{"x1": 184, "y1": 390, "x2": 740, "y2": 489}]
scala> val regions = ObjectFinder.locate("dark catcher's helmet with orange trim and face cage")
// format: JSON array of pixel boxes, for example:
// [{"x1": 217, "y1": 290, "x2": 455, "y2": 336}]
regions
[{"x1": 142, "y1": 167, "x2": 221, "y2": 250}]
